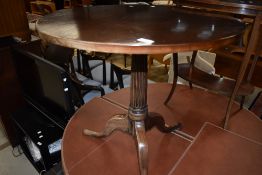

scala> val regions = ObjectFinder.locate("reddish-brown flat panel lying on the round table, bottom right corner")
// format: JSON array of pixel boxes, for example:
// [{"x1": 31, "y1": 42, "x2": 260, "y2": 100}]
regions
[{"x1": 170, "y1": 123, "x2": 262, "y2": 175}]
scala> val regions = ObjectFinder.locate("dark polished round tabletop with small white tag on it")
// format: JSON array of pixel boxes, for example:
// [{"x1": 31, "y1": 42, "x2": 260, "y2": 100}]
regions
[{"x1": 36, "y1": 5, "x2": 244, "y2": 54}]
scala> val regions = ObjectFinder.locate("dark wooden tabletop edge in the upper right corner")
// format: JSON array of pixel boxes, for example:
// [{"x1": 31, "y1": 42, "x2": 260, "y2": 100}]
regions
[{"x1": 175, "y1": 0, "x2": 262, "y2": 16}]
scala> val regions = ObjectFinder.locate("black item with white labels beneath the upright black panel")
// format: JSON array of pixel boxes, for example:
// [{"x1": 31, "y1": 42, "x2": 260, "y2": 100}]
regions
[{"x1": 12, "y1": 105, "x2": 63, "y2": 172}]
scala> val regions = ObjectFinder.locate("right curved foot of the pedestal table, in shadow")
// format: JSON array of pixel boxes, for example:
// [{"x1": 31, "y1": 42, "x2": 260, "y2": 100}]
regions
[{"x1": 145, "y1": 112, "x2": 182, "y2": 133}]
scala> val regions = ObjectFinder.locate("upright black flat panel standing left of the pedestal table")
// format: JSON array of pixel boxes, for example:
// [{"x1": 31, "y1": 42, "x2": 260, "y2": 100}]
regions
[{"x1": 12, "y1": 42, "x2": 79, "y2": 127}]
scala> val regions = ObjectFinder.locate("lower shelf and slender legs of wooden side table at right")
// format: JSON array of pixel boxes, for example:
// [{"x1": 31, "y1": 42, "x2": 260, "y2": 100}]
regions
[{"x1": 165, "y1": 14, "x2": 261, "y2": 108}]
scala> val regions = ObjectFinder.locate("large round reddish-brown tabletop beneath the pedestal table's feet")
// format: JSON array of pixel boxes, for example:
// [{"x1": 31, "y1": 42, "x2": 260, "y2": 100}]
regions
[{"x1": 62, "y1": 84, "x2": 262, "y2": 175}]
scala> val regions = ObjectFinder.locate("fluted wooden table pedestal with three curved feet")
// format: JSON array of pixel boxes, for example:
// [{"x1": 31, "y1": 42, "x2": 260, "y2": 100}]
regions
[{"x1": 83, "y1": 55, "x2": 181, "y2": 175}]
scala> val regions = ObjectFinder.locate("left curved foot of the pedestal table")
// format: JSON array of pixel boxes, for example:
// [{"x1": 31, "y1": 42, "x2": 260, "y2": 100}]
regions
[{"x1": 83, "y1": 114, "x2": 129, "y2": 137}]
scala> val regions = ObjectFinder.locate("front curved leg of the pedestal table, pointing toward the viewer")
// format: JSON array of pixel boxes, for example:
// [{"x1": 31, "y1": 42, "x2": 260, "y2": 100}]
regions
[{"x1": 134, "y1": 121, "x2": 148, "y2": 175}]
